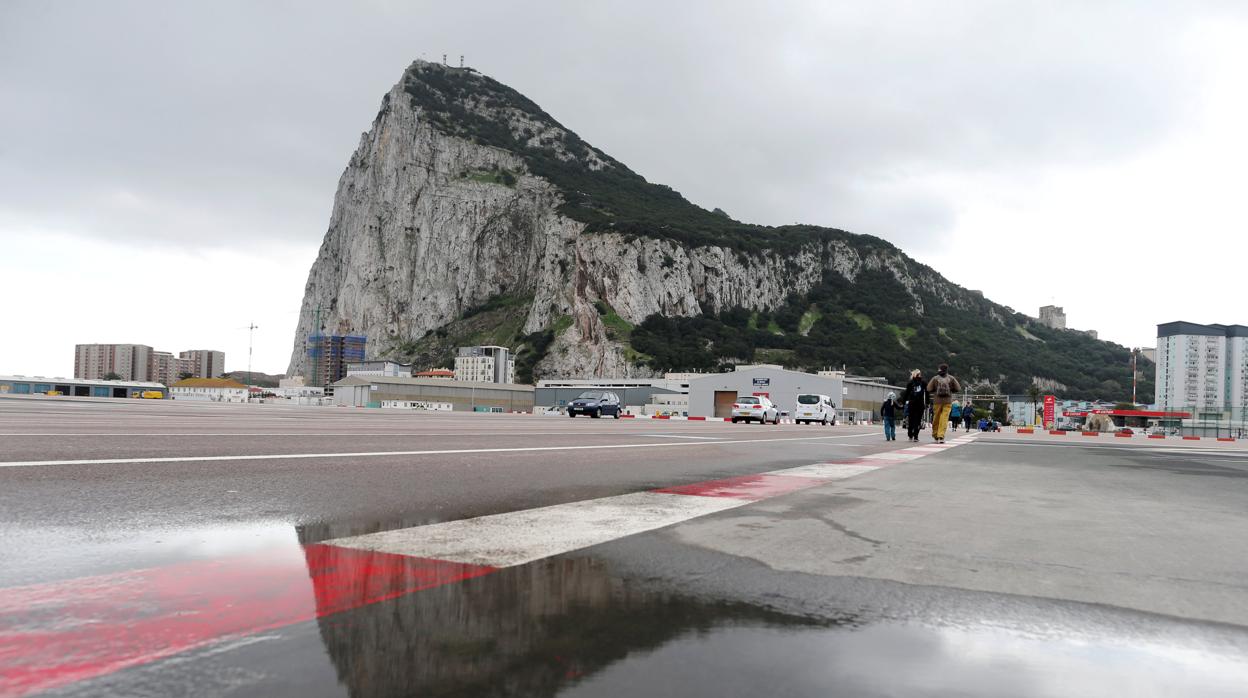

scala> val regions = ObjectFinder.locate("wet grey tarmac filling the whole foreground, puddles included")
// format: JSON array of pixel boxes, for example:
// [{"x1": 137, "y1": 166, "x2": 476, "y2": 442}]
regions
[{"x1": 0, "y1": 400, "x2": 1248, "y2": 697}]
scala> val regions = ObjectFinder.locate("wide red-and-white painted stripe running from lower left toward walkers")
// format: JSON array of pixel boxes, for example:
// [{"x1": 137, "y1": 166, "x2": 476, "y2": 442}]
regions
[{"x1": 0, "y1": 436, "x2": 973, "y2": 698}]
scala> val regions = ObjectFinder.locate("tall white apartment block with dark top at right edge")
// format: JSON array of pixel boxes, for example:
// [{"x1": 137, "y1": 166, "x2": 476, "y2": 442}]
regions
[{"x1": 1156, "y1": 322, "x2": 1248, "y2": 413}]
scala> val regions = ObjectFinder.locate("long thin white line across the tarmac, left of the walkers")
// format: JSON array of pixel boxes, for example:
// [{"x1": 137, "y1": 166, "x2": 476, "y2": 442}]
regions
[{"x1": 0, "y1": 435, "x2": 874, "y2": 468}]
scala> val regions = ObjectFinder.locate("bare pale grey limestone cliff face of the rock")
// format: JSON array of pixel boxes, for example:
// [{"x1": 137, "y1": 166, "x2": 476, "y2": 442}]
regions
[{"x1": 288, "y1": 62, "x2": 967, "y2": 377}]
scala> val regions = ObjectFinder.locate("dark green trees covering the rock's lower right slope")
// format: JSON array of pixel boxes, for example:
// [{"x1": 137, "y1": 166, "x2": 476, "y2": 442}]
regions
[{"x1": 631, "y1": 271, "x2": 1153, "y2": 402}]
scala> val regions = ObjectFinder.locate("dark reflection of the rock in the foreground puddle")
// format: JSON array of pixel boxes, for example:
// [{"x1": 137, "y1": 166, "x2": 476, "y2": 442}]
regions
[{"x1": 307, "y1": 558, "x2": 816, "y2": 697}]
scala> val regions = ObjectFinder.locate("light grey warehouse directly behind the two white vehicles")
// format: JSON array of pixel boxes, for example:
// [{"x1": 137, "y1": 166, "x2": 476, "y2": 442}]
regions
[{"x1": 689, "y1": 365, "x2": 902, "y2": 420}]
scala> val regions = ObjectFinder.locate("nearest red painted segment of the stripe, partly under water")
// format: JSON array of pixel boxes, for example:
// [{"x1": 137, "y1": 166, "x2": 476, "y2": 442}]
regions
[{"x1": 0, "y1": 544, "x2": 494, "y2": 698}]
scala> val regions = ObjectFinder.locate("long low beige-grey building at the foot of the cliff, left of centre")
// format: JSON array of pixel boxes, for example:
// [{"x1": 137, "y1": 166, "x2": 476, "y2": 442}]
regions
[{"x1": 332, "y1": 376, "x2": 533, "y2": 412}]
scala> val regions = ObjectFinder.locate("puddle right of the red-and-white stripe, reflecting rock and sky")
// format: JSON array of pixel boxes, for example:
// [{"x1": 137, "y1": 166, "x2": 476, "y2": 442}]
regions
[{"x1": 302, "y1": 558, "x2": 1248, "y2": 698}]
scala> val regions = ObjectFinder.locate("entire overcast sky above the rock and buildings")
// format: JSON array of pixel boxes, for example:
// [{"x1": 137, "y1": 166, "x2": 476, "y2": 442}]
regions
[{"x1": 0, "y1": 0, "x2": 1248, "y2": 376}]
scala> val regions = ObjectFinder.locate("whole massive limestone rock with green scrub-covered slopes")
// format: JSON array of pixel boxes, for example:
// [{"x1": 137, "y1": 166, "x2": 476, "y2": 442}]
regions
[{"x1": 287, "y1": 61, "x2": 1153, "y2": 402}]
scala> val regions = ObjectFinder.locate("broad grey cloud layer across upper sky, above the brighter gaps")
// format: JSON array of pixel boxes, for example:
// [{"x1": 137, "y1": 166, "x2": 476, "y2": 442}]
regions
[{"x1": 0, "y1": 1, "x2": 1239, "y2": 247}]
